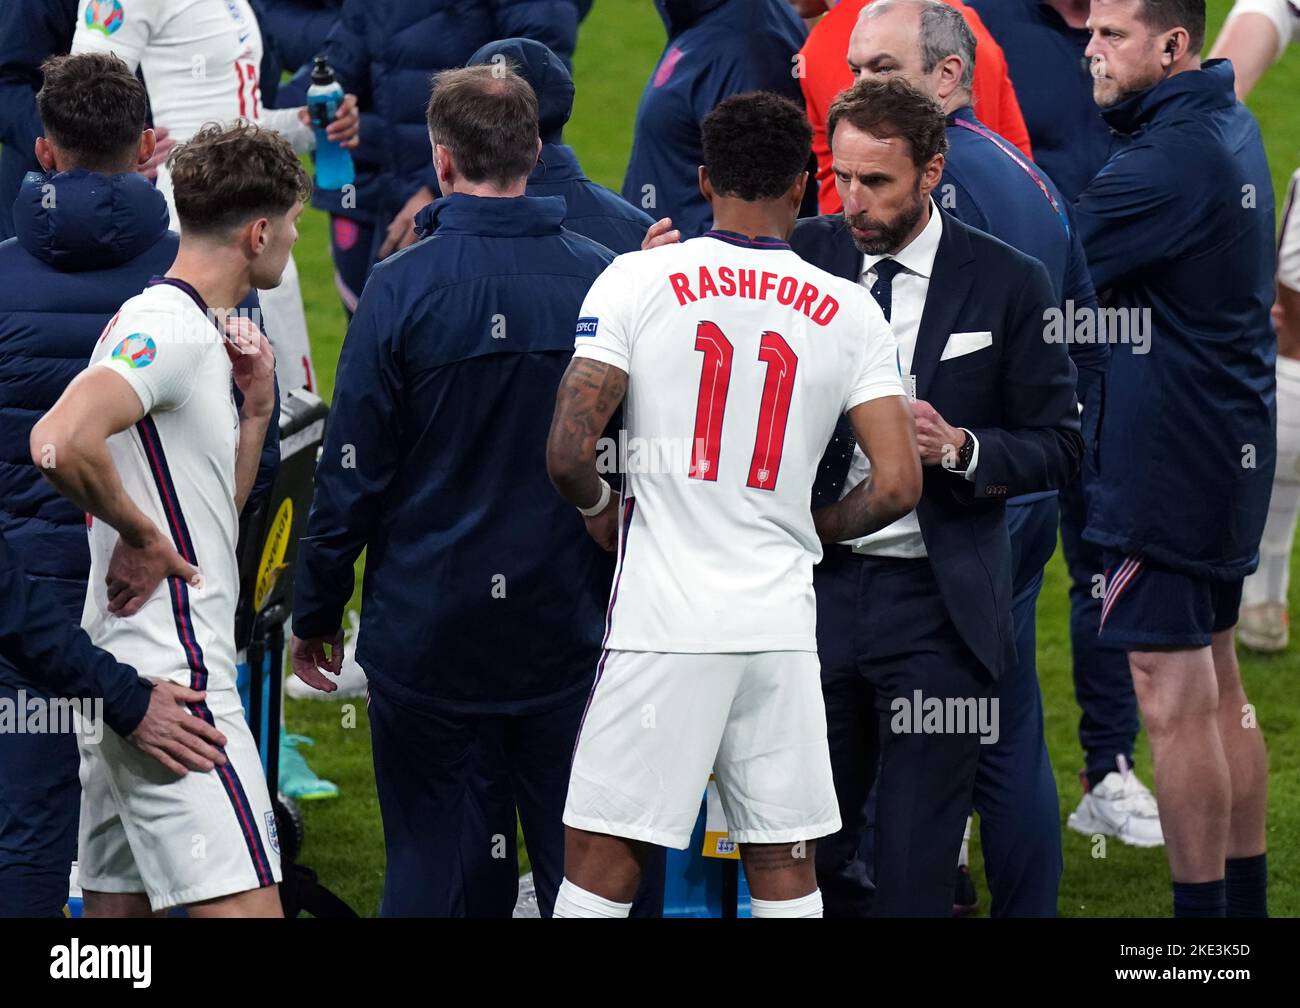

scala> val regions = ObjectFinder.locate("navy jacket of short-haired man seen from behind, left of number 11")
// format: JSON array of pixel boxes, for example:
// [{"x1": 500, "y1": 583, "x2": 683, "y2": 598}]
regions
[{"x1": 294, "y1": 194, "x2": 614, "y2": 714}]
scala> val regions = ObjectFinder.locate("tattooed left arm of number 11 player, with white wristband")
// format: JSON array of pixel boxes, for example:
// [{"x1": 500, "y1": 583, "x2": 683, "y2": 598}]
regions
[{"x1": 546, "y1": 356, "x2": 628, "y2": 549}]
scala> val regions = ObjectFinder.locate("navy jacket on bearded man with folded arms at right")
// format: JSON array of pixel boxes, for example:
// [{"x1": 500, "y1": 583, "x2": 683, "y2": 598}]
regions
[{"x1": 1076, "y1": 60, "x2": 1277, "y2": 580}]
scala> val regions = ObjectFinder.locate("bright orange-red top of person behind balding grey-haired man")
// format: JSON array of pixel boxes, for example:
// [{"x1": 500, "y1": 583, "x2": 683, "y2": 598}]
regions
[{"x1": 796, "y1": 0, "x2": 1032, "y2": 213}]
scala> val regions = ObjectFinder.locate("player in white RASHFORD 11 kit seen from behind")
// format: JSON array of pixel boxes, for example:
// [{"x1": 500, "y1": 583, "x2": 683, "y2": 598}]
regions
[{"x1": 547, "y1": 92, "x2": 920, "y2": 917}]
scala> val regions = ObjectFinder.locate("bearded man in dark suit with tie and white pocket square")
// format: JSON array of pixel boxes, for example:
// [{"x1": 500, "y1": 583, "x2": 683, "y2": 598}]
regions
[{"x1": 792, "y1": 79, "x2": 1083, "y2": 916}]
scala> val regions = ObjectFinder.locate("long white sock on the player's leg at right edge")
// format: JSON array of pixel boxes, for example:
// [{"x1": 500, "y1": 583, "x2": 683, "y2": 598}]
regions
[{"x1": 1242, "y1": 356, "x2": 1300, "y2": 605}]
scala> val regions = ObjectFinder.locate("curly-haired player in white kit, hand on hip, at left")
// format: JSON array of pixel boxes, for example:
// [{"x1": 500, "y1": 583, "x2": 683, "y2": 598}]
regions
[{"x1": 31, "y1": 124, "x2": 309, "y2": 917}]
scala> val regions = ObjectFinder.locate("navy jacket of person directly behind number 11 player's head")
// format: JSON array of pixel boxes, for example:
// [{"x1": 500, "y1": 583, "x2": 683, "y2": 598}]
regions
[{"x1": 623, "y1": 0, "x2": 816, "y2": 238}]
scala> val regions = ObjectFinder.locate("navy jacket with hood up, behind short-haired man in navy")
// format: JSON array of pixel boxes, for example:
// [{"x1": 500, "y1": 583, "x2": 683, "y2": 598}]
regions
[{"x1": 467, "y1": 39, "x2": 654, "y2": 255}]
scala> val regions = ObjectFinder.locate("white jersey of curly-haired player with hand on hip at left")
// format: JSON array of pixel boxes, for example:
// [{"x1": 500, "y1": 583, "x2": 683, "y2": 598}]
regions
[{"x1": 82, "y1": 281, "x2": 239, "y2": 689}]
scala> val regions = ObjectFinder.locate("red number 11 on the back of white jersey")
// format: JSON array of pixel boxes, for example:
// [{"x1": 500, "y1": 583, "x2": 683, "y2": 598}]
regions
[{"x1": 690, "y1": 321, "x2": 800, "y2": 490}]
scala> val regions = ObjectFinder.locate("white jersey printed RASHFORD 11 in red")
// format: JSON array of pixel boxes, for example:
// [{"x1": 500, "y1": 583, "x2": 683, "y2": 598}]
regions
[{"x1": 575, "y1": 232, "x2": 904, "y2": 652}]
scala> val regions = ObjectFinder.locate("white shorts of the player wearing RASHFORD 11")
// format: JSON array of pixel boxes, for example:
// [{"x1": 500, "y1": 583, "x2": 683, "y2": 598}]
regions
[{"x1": 564, "y1": 650, "x2": 840, "y2": 849}]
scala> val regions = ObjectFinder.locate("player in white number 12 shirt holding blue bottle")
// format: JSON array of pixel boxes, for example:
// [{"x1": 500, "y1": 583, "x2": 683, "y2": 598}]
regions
[{"x1": 73, "y1": 0, "x2": 359, "y2": 390}]
